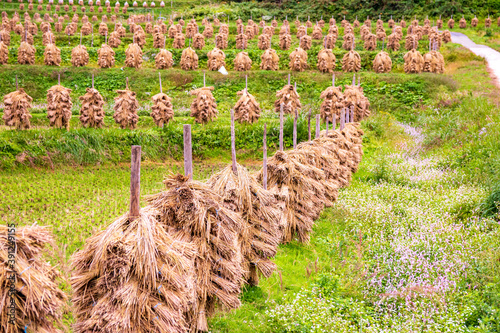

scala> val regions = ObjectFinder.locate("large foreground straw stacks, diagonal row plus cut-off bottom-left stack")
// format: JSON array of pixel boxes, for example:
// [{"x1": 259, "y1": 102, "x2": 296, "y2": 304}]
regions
[{"x1": 0, "y1": 74, "x2": 363, "y2": 333}]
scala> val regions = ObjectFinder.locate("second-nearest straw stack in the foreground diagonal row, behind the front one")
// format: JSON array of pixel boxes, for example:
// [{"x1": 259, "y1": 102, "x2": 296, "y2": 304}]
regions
[{"x1": 148, "y1": 175, "x2": 244, "y2": 332}]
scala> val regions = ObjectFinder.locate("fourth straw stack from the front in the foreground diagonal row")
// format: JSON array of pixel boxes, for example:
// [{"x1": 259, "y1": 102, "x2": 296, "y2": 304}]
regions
[{"x1": 257, "y1": 151, "x2": 335, "y2": 243}]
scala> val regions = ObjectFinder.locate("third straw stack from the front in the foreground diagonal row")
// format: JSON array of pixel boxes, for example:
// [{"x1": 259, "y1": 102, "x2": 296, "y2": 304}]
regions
[{"x1": 207, "y1": 164, "x2": 282, "y2": 286}]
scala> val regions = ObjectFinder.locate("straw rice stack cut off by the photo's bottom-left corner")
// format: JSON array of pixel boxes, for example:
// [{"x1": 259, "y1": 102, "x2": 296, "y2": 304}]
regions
[{"x1": 0, "y1": 225, "x2": 67, "y2": 333}]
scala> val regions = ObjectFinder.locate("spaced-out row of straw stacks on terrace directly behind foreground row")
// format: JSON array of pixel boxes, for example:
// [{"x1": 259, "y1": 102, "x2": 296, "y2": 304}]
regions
[{"x1": 3, "y1": 74, "x2": 369, "y2": 130}]
